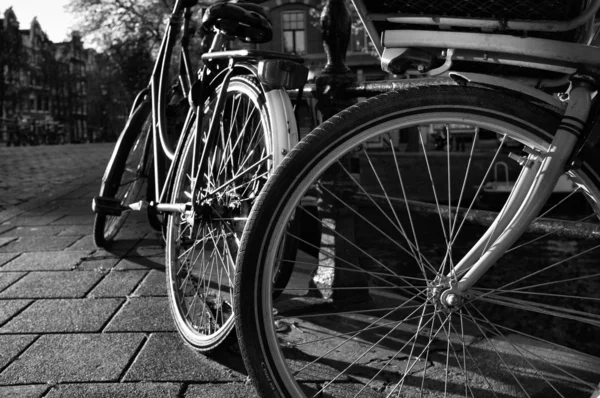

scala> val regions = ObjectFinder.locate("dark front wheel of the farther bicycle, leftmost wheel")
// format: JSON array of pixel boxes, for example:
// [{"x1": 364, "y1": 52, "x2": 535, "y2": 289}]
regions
[{"x1": 93, "y1": 102, "x2": 152, "y2": 248}]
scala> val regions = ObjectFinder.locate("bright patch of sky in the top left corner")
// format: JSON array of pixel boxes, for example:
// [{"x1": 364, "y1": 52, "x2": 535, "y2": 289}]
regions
[{"x1": 0, "y1": 0, "x2": 74, "y2": 42}]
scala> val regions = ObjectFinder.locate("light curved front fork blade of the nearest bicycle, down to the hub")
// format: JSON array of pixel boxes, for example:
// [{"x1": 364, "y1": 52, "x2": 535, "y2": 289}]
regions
[{"x1": 442, "y1": 81, "x2": 593, "y2": 305}]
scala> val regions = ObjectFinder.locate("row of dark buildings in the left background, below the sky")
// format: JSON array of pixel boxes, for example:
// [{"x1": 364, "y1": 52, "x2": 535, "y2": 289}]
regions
[{"x1": 0, "y1": 8, "x2": 113, "y2": 145}]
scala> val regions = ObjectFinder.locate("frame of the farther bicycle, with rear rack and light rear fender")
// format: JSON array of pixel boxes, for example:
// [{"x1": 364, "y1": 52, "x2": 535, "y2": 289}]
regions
[{"x1": 135, "y1": 15, "x2": 306, "y2": 219}]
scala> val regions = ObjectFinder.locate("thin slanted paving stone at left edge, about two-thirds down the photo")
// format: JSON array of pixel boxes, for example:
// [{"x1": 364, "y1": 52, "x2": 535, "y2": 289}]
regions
[{"x1": 0, "y1": 250, "x2": 90, "y2": 271}]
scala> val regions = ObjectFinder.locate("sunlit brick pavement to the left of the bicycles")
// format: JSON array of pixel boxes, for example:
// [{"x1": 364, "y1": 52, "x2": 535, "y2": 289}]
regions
[{"x1": 0, "y1": 144, "x2": 255, "y2": 398}]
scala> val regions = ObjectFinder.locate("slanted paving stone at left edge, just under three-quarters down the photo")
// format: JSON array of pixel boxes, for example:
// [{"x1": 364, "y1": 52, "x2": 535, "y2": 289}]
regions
[{"x1": 0, "y1": 271, "x2": 102, "y2": 298}]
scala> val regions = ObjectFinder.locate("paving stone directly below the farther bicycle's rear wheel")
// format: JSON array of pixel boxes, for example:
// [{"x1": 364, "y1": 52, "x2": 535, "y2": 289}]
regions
[{"x1": 124, "y1": 333, "x2": 242, "y2": 382}]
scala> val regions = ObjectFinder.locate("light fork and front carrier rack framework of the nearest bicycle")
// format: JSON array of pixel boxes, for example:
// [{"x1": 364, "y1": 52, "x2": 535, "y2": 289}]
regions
[{"x1": 352, "y1": 0, "x2": 600, "y2": 301}]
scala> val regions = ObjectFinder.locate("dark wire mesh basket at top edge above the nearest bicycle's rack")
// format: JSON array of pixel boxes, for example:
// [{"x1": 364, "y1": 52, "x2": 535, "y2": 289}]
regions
[{"x1": 365, "y1": 0, "x2": 584, "y2": 21}]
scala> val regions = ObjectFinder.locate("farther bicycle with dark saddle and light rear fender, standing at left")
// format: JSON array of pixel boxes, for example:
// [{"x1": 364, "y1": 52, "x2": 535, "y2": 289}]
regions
[{"x1": 93, "y1": 0, "x2": 308, "y2": 351}]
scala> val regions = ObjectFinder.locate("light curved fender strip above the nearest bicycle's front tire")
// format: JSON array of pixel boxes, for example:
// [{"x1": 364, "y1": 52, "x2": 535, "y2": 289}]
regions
[{"x1": 448, "y1": 72, "x2": 567, "y2": 111}]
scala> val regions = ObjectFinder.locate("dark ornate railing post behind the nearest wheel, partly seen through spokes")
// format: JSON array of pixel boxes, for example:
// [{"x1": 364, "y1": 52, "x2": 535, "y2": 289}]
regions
[{"x1": 310, "y1": 0, "x2": 369, "y2": 304}]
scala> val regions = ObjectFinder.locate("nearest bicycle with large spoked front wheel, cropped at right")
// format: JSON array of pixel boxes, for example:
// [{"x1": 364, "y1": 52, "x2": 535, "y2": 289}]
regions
[{"x1": 234, "y1": 0, "x2": 600, "y2": 397}]
